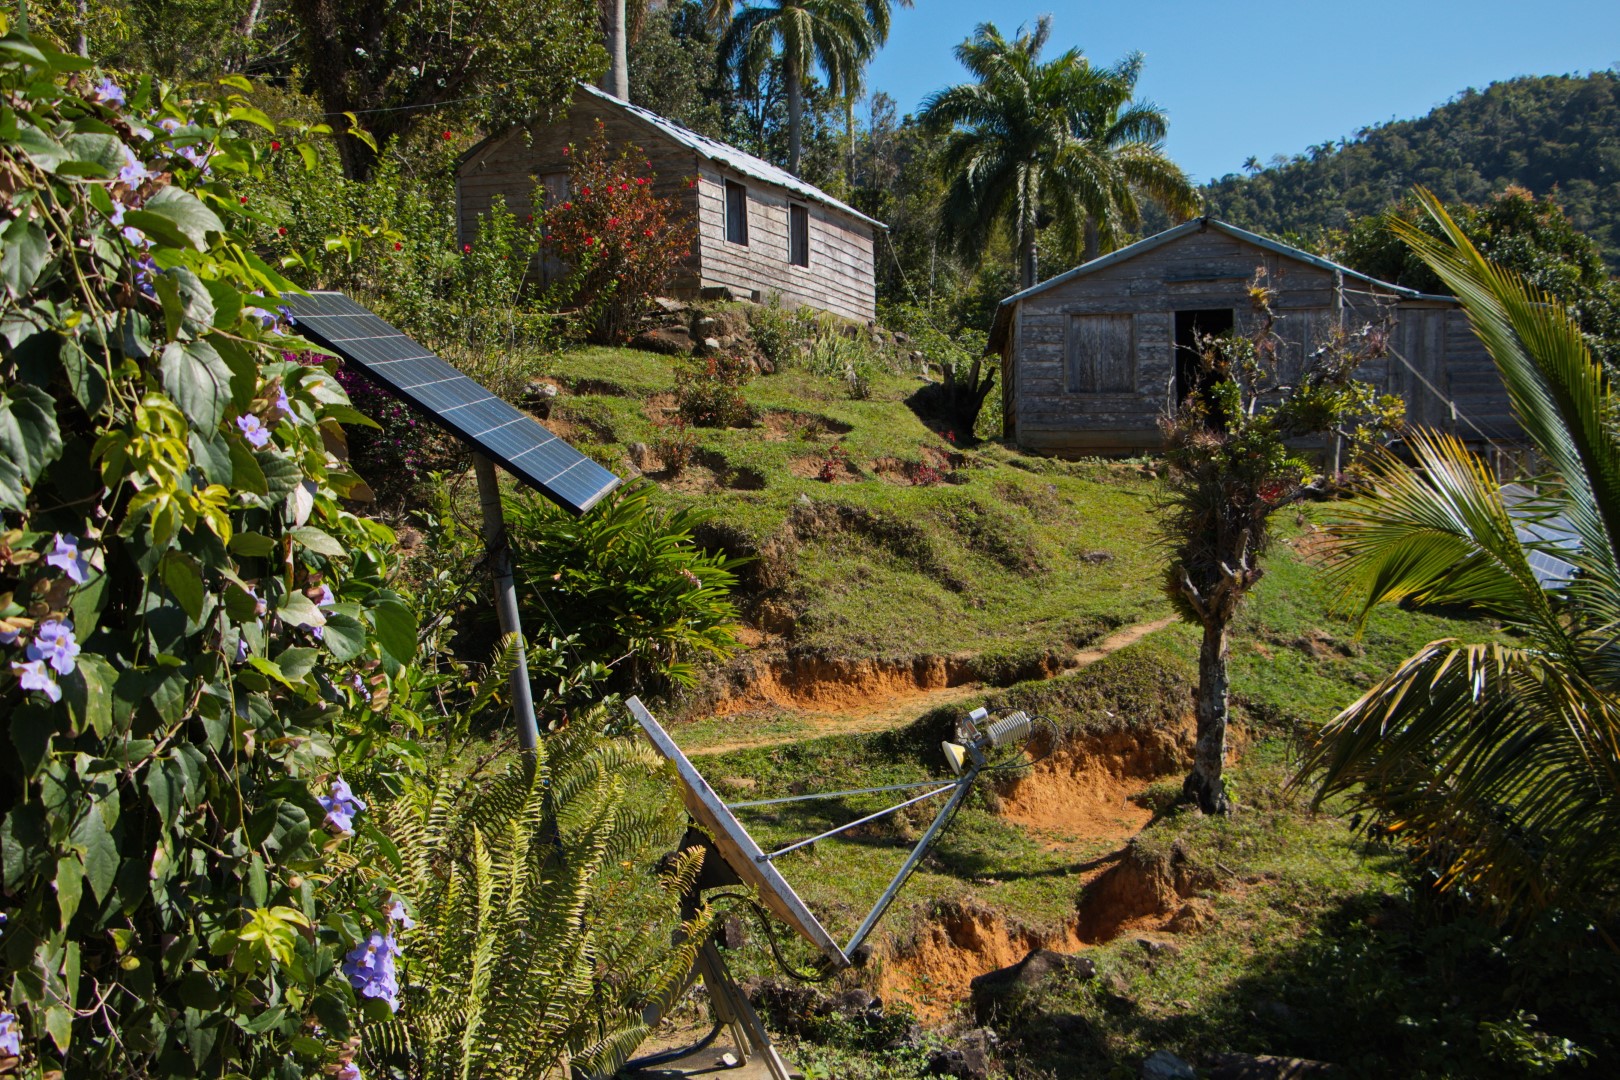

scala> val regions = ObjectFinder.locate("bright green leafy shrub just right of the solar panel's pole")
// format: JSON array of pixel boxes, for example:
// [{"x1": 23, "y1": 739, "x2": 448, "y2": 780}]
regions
[{"x1": 509, "y1": 489, "x2": 740, "y2": 688}]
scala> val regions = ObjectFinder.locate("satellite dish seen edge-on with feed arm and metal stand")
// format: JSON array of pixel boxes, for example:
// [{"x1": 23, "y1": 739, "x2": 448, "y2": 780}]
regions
[{"x1": 625, "y1": 698, "x2": 1034, "y2": 1080}]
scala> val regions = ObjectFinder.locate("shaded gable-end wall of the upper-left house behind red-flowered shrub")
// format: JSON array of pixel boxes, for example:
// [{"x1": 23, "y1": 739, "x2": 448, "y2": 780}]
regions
[{"x1": 455, "y1": 92, "x2": 698, "y2": 295}]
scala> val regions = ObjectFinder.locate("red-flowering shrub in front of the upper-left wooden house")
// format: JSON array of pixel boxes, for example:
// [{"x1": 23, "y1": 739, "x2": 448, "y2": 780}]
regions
[{"x1": 544, "y1": 120, "x2": 693, "y2": 345}]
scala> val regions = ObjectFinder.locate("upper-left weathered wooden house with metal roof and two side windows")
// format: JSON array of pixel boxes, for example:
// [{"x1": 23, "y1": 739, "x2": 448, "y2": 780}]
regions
[{"x1": 455, "y1": 84, "x2": 885, "y2": 319}]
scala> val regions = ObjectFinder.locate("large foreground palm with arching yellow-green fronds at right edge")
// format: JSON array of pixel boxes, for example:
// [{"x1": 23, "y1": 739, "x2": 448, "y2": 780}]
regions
[{"x1": 1301, "y1": 193, "x2": 1620, "y2": 918}]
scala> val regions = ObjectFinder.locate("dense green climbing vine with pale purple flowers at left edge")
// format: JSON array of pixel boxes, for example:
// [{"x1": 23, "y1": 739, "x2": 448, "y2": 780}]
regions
[{"x1": 0, "y1": 26, "x2": 416, "y2": 1077}]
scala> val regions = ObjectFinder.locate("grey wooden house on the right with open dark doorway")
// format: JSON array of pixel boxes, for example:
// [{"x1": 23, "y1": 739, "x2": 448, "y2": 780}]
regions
[{"x1": 990, "y1": 217, "x2": 1516, "y2": 455}]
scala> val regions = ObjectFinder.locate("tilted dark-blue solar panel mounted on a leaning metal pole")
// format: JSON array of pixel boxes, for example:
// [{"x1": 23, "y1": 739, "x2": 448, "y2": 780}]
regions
[{"x1": 282, "y1": 293, "x2": 620, "y2": 513}]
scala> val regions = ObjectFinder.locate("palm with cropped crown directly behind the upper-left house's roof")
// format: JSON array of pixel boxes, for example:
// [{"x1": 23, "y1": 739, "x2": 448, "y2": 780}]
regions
[{"x1": 708, "y1": 0, "x2": 889, "y2": 175}]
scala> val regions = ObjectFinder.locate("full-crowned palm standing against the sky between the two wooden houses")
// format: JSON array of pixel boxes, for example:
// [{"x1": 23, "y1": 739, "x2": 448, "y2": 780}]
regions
[{"x1": 922, "y1": 16, "x2": 1200, "y2": 288}]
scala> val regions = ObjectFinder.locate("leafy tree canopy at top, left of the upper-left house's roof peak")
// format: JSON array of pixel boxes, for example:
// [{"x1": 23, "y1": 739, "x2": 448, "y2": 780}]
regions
[{"x1": 290, "y1": 0, "x2": 603, "y2": 180}]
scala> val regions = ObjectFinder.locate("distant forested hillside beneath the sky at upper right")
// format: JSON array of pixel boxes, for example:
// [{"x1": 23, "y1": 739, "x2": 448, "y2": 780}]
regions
[{"x1": 1204, "y1": 71, "x2": 1620, "y2": 272}]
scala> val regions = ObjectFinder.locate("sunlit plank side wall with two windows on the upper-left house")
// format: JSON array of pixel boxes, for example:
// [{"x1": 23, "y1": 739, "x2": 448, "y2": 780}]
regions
[{"x1": 698, "y1": 160, "x2": 876, "y2": 319}]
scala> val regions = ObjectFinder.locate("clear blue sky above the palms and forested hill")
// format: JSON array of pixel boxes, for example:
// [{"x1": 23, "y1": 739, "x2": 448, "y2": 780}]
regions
[{"x1": 868, "y1": 0, "x2": 1620, "y2": 181}]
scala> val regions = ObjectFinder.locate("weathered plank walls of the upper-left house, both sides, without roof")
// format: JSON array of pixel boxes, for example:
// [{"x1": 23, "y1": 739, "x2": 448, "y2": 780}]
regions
[{"x1": 457, "y1": 92, "x2": 876, "y2": 319}]
